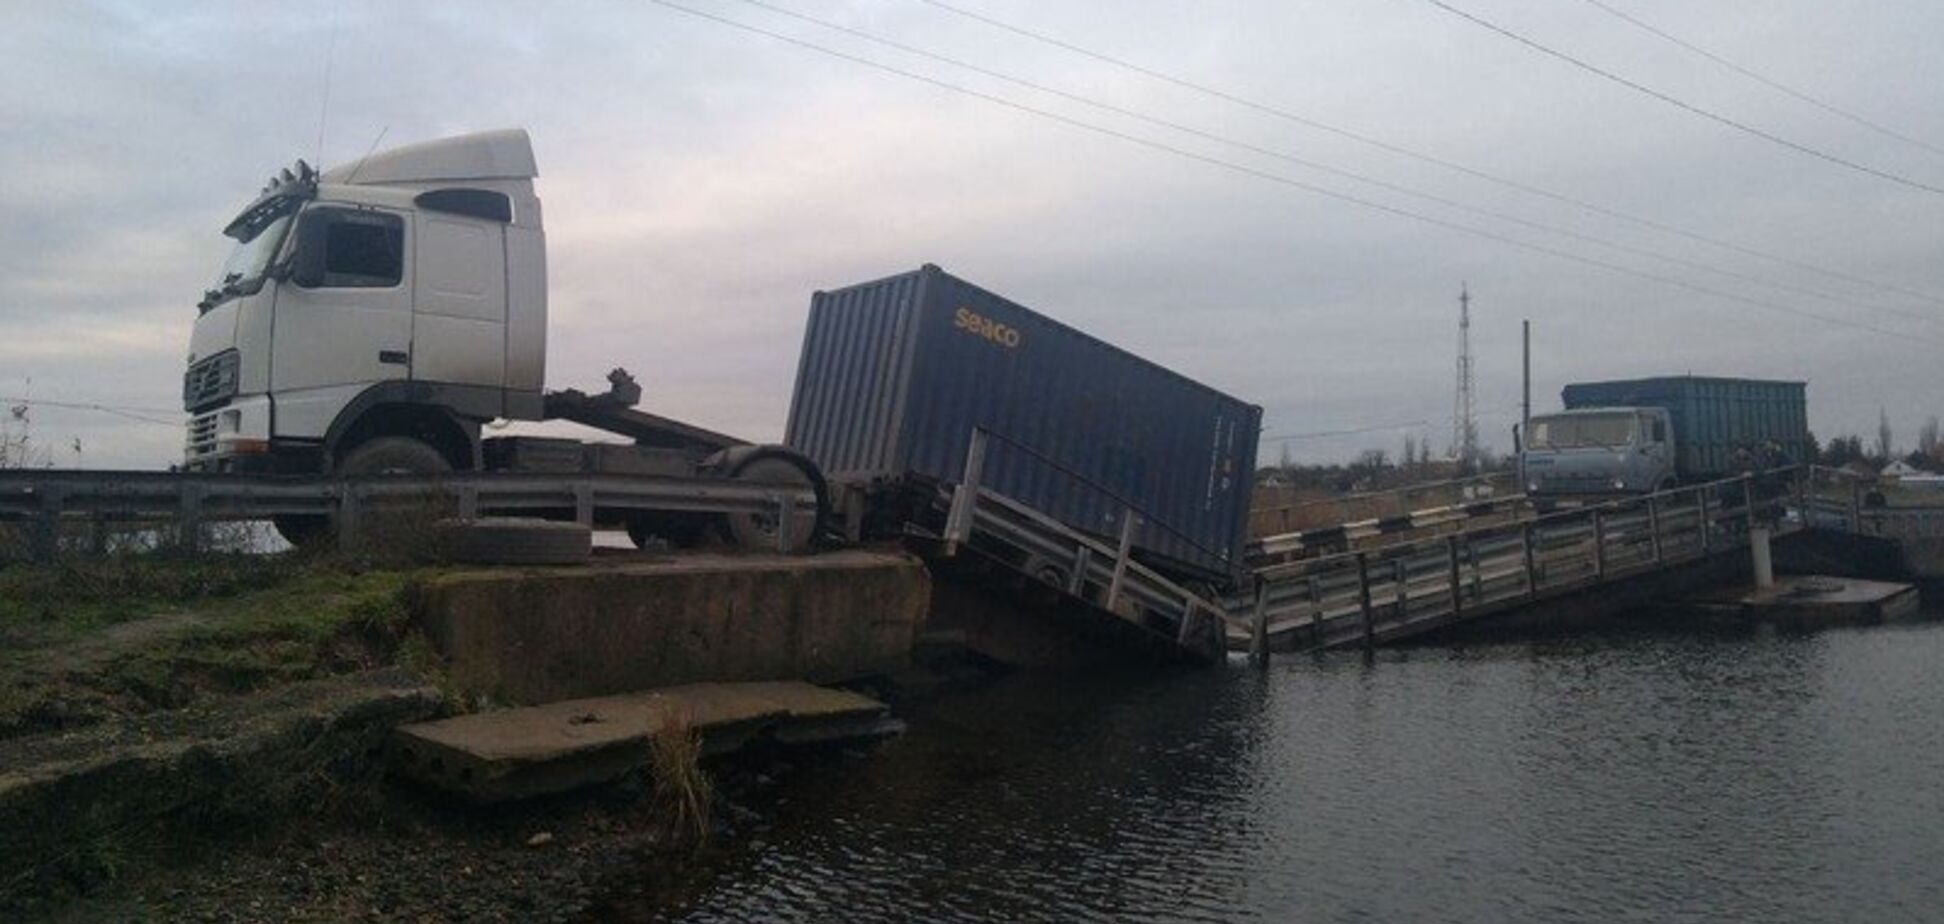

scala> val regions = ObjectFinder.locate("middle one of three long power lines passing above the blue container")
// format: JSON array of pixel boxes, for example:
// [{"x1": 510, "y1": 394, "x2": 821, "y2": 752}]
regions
[{"x1": 743, "y1": 0, "x2": 1944, "y2": 323}]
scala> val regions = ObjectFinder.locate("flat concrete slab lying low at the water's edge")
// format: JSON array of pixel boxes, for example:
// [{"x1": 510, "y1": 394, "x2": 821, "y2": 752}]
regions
[{"x1": 395, "y1": 683, "x2": 896, "y2": 801}]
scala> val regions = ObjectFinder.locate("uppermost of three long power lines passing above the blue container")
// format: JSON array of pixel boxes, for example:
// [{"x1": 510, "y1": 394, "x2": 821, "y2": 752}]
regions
[{"x1": 918, "y1": 0, "x2": 1944, "y2": 305}]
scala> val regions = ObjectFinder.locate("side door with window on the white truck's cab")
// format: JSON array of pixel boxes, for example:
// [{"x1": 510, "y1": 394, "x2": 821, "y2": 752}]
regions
[{"x1": 270, "y1": 206, "x2": 412, "y2": 438}]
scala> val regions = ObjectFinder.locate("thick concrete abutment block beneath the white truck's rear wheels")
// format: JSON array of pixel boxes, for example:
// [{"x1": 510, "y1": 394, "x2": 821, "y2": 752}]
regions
[{"x1": 418, "y1": 551, "x2": 931, "y2": 704}]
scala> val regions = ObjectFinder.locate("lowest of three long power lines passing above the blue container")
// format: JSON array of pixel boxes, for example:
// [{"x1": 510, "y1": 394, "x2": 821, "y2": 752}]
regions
[{"x1": 649, "y1": 0, "x2": 1944, "y2": 342}]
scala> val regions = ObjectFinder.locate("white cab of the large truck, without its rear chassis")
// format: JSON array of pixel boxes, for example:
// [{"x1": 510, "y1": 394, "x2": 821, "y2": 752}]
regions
[{"x1": 183, "y1": 130, "x2": 546, "y2": 473}]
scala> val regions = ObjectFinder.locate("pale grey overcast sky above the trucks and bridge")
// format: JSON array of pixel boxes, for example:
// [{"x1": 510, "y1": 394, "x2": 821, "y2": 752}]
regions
[{"x1": 0, "y1": 0, "x2": 1944, "y2": 467}]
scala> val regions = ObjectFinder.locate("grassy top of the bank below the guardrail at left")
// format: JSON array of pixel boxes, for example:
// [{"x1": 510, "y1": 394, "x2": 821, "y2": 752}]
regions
[{"x1": 0, "y1": 554, "x2": 441, "y2": 739}]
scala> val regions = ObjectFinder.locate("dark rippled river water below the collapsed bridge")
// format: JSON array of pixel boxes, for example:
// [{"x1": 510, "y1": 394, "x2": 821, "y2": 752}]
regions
[{"x1": 614, "y1": 622, "x2": 1944, "y2": 924}]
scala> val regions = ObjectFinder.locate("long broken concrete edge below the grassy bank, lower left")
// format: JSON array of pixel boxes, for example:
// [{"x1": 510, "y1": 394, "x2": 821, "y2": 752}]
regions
[{"x1": 0, "y1": 669, "x2": 445, "y2": 908}]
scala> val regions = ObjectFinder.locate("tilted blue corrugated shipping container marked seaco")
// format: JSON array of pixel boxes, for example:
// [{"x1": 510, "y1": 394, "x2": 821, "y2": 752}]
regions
[{"x1": 785, "y1": 265, "x2": 1262, "y2": 578}]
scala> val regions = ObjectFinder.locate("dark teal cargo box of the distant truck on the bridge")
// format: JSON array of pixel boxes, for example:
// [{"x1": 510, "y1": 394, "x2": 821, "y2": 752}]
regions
[{"x1": 1559, "y1": 375, "x2": 1810, "y2": 479}]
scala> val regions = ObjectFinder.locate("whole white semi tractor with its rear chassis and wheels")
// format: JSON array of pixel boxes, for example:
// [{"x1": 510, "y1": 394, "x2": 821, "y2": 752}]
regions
[{"x1": 183, "y1": 128, "x2": 828, "y2": 551}]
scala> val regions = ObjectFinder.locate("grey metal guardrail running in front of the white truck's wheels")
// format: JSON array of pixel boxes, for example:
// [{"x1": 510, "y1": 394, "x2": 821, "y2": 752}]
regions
[{"x1": 0, "y1": 469, "x2": 816, "y2": 556}]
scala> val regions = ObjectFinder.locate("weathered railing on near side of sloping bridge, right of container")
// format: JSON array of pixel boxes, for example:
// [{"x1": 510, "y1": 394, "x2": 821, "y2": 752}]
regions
[{"x1": 1221, "y1": 467, "x2": 1810, "y2": 650}]
